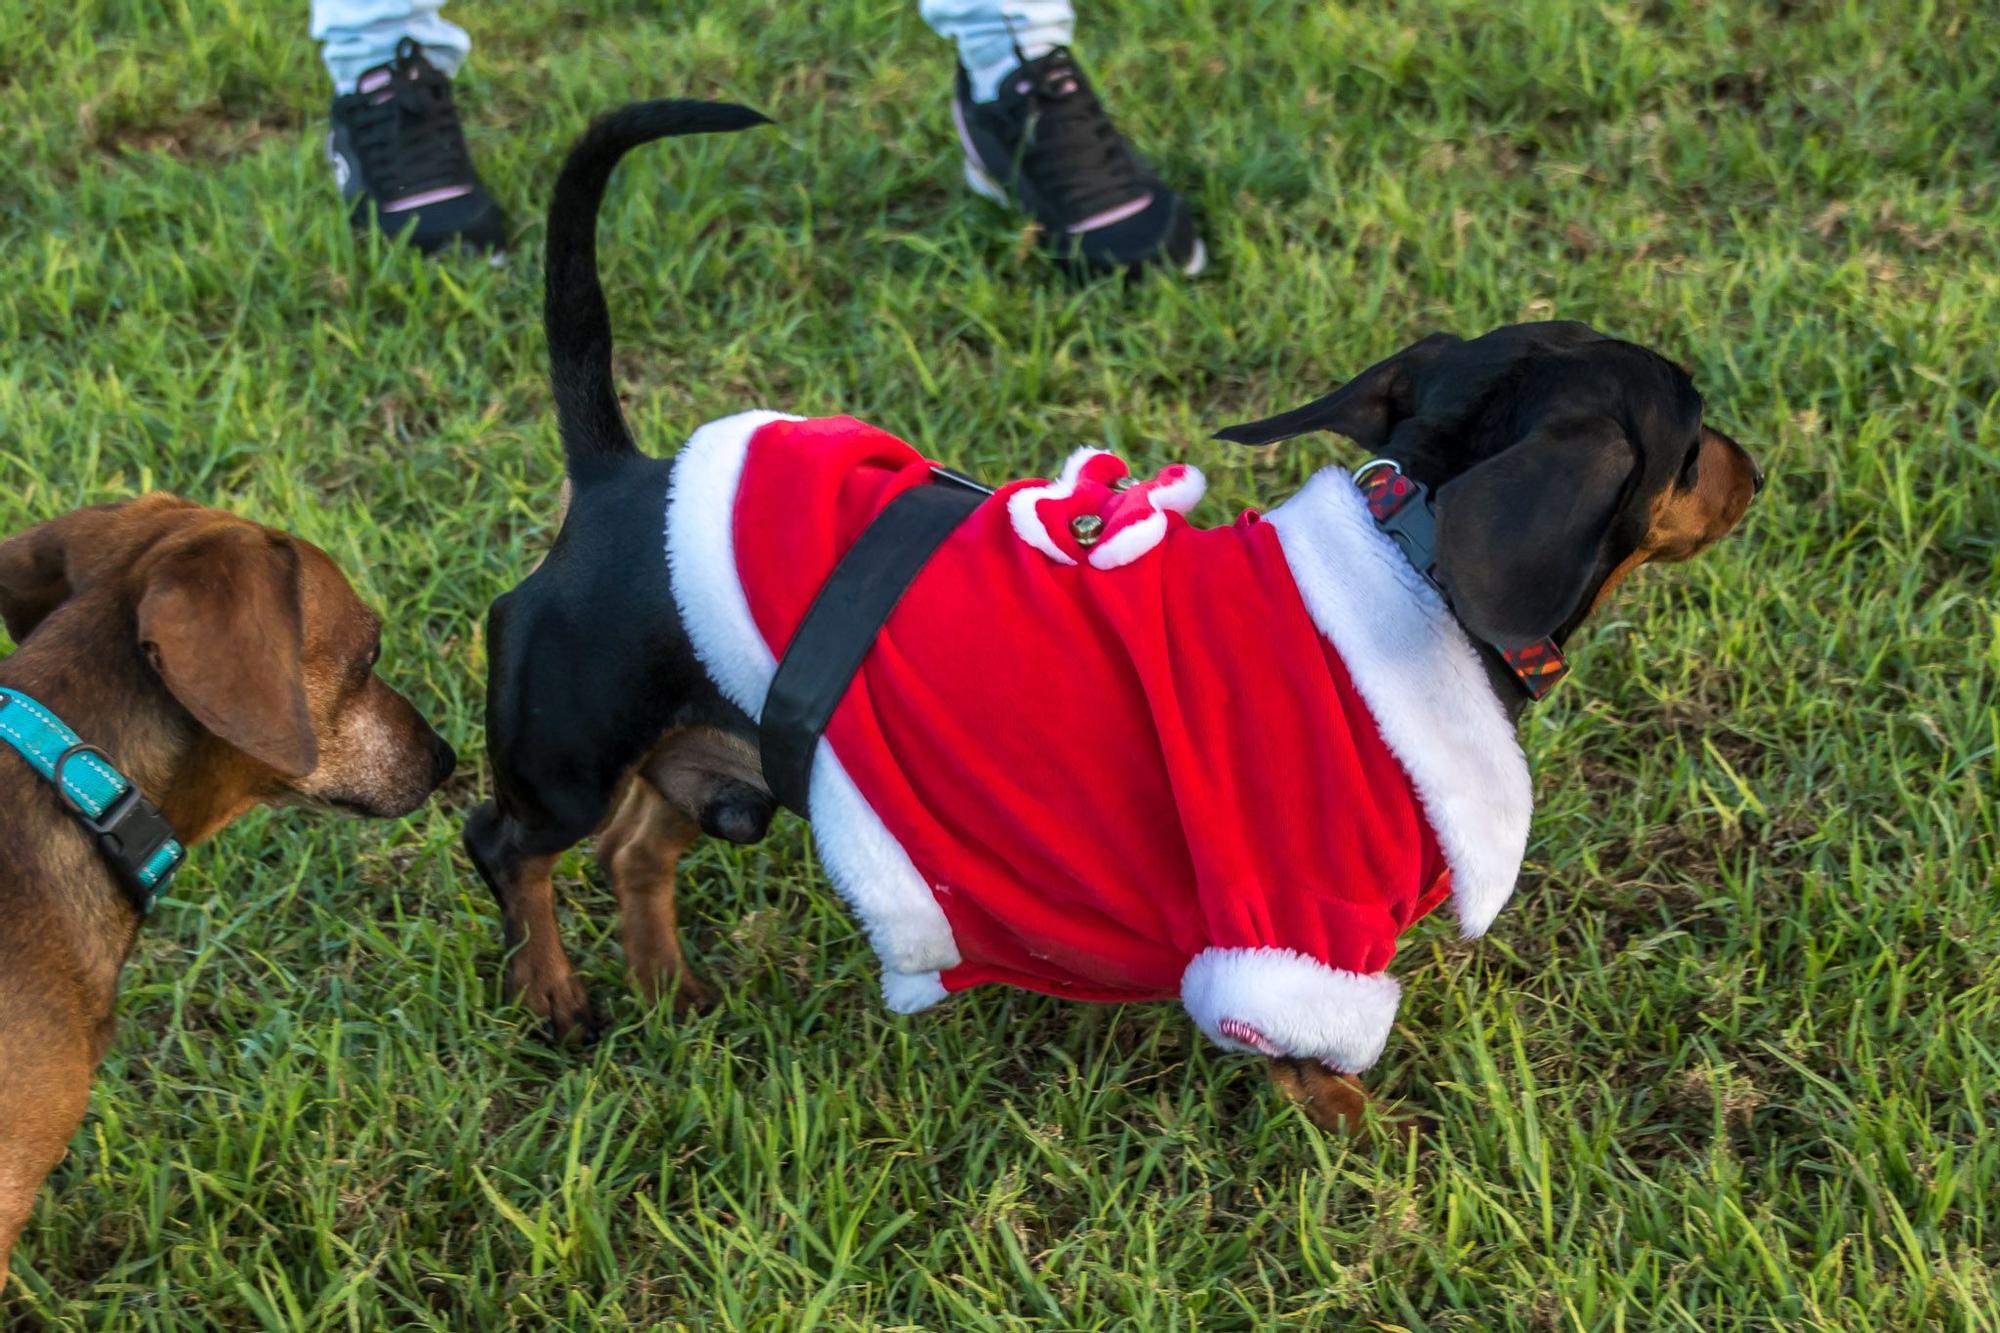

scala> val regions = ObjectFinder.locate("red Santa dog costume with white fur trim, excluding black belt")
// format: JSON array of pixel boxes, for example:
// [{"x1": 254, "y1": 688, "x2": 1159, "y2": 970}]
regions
[{"x1": 666, "y1": 412, "x2": 1530, "y2": 1071}]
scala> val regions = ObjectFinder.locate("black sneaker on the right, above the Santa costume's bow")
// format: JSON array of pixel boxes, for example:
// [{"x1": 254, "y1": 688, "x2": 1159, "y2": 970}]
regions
[{"x1": 952, "y1": 46, "x2": 1208, "y2": 276}]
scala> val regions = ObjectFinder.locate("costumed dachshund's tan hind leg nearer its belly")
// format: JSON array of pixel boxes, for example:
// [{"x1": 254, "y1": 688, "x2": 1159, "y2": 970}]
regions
[{"x1": 598, "y1": 779, "x2": 718, "y2": 1011}]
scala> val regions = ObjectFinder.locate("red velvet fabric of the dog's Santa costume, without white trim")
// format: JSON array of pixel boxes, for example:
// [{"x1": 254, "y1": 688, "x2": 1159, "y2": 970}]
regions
[{"x1": 732, "y1": 416, "x2": 1448, "y2": 1001}]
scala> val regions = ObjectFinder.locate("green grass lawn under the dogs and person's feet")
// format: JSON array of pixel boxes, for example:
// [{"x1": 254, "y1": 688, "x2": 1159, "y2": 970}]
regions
[{"x1": 0, "y1": 0, "x2": 2000, "y2": 1329}]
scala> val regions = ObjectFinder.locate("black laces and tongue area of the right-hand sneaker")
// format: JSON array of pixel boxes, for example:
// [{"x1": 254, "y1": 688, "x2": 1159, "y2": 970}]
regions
[{"x1": 1020, "y1": 46, "x2": 1148, "y2": 216}]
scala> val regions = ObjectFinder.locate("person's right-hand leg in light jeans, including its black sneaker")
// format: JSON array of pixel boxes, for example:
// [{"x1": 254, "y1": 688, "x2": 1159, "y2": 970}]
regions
[{"x1": 922, "y1": 0, "x2": 1208, "y2": 274}]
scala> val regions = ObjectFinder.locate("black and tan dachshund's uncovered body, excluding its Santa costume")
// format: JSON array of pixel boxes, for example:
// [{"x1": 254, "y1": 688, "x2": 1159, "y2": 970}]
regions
[{"x1": 466, "y1": 102, "x2": 1762, "y2": 1127}]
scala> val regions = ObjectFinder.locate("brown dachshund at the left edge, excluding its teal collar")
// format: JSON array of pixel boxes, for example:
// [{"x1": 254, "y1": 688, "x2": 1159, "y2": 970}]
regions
[{"x1": 0, "y1": 494, "x2": 456, "y2": 1281}]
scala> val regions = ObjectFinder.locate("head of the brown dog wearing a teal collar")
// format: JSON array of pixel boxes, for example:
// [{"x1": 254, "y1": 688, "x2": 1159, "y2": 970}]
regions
[{"x1": 0, "y1": 494, "x2": 456, "y2": 837}]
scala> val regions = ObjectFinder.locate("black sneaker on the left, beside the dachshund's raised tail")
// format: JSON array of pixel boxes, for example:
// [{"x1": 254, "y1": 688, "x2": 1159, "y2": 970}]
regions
[{"x1": 326, "y1": 38, "x2": 506, "y2": 254}]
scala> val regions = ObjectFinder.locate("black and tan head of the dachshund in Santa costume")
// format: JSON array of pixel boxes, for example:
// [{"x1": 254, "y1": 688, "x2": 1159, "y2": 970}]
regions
[{"x1": 1220, "y1": 322, "x2": 1764, "y2": 648}]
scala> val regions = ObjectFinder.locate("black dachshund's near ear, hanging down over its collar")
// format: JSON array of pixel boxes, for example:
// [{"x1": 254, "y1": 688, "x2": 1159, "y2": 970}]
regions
[{"x1": 1438, "y1": 416, "x2": 1636, "y2": 648}]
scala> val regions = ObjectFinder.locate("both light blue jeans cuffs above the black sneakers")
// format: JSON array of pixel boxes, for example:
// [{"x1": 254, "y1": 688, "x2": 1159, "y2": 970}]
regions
[{"x1": 312, "y1": 0, "x2": 1076, "y2": 102}]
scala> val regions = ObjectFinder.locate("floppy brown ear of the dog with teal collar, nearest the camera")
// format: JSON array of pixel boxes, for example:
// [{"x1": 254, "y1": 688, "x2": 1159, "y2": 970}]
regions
[{"x1": 138, "y1": 526, "x2": 320, "y2": 779}]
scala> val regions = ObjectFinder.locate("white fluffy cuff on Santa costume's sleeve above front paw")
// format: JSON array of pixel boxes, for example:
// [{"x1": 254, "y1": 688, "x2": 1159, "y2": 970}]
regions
[{"x1": 1180, "y1": 949, "x2": 1402, "y2": 1073}]
